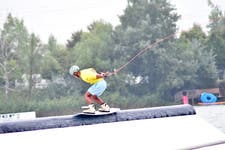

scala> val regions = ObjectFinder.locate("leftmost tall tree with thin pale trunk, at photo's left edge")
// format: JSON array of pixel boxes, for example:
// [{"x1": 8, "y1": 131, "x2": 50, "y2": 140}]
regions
[{"x1": 0, "y1": 14, "x2": 28, "y2": 99}]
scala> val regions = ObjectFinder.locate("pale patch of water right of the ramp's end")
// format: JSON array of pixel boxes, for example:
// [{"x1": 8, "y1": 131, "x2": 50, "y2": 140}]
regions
[{"x1": 194, "y1": 105, "x2": 225, "y2": 133}]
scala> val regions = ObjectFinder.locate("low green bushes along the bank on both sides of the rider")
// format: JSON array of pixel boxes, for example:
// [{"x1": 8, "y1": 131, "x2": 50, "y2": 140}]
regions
[{"x1": 0, "y1": 91, "x2": 176, "y2": 117}]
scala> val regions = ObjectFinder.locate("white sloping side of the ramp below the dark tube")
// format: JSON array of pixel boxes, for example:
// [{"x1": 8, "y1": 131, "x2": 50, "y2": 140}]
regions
[{"x1": 0, "y1": 115, "x2": 225, "y2": 150}]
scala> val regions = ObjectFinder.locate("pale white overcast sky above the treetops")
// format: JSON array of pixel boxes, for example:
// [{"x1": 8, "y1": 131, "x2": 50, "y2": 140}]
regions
[{"x1": 0, "y1": 0, "x2": 225, "y2": 44}]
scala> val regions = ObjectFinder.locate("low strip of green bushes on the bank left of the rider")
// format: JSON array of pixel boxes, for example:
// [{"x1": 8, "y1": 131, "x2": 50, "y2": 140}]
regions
[{"x1": 0, "y1": 97, "x2": 84, "y2": 117}]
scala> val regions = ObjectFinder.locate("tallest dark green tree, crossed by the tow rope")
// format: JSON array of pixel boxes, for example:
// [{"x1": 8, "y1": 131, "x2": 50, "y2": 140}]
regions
[{"x1": 114, "y1": 0, "x2": 179, "y2": 96}]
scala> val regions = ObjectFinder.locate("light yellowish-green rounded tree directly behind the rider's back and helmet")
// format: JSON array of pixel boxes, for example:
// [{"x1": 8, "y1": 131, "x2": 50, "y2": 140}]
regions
[{"x1": 72, "y1": 20, "x2": 114, "y2": 71}]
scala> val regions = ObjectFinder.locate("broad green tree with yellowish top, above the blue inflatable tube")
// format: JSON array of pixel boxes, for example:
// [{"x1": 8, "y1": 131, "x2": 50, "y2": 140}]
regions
[{"x1": 173, "y1": 38, "x2": 217, "y2": 89}]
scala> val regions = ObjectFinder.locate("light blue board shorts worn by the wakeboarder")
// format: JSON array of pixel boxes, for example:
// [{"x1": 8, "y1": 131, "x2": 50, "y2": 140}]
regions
[{"x1": 88, "y1": 80, "x2": 107, "y2": 96}]
